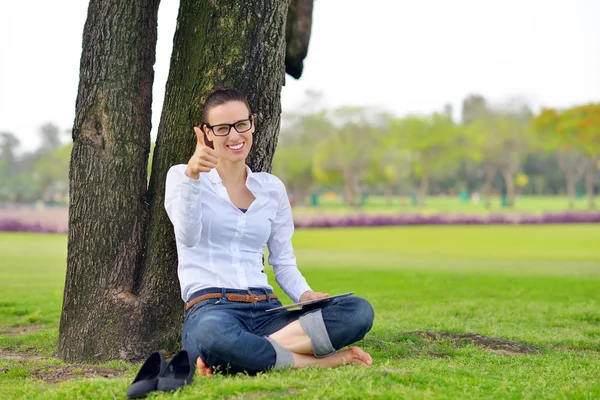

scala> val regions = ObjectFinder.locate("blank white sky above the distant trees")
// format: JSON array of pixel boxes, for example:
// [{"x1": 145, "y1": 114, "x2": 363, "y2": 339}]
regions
[{"x1": 0, "y1": 0, "x2": 600, "y2": 150}]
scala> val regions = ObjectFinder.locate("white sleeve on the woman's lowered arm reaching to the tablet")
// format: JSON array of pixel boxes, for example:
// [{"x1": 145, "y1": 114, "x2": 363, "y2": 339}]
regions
[{"x1": 267, "y1": 183, "x2": 311, "y2": 302}]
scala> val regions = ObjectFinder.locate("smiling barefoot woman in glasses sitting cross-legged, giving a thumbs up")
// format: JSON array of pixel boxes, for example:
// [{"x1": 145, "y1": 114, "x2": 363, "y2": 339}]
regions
[{"x1": 165, "y1": 88, "x2": 374, "y2": 376}]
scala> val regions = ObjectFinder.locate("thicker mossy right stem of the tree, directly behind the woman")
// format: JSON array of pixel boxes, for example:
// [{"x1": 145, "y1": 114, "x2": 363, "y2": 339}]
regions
[{"x1": 137, "y1": 0, "x2": 287, "y2": 360}]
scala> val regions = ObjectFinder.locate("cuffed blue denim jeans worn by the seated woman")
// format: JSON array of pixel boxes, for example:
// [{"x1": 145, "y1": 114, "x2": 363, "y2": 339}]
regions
[{"x1": 182, "y1": 288, "x2": 374, "y2": 374}]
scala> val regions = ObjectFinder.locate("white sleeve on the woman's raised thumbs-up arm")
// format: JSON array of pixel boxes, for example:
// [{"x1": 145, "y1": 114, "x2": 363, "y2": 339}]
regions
[{"x1": 165, "y1": 164, "x2": 202, "y2": 247}]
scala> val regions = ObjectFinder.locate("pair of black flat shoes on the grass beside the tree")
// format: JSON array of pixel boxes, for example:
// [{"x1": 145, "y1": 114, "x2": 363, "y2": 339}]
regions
[{"x1": 127, "y1": 350, "x2": 196, "y2": 399}]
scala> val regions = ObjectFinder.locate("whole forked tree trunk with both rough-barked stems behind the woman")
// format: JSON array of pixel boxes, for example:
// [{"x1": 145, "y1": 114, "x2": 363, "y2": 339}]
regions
[{"x1": 59, "y1": 0, "x2": 288, "y2": 361}]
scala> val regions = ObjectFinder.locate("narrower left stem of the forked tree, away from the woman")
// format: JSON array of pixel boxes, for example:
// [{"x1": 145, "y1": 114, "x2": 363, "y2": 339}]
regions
[{"x1": 58, "y1": 0, "x2": 158, "y2": 361}]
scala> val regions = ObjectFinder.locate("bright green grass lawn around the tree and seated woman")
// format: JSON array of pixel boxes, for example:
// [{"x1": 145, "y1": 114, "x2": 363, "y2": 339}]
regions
[{"x1": 0, "y1": 225, "x2": 600, "y2": 399}]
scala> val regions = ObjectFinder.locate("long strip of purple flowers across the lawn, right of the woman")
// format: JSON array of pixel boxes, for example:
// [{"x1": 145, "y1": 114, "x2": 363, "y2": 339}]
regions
[{"x1": 295, "y1": 212, "x2": 600, "y2": 228}]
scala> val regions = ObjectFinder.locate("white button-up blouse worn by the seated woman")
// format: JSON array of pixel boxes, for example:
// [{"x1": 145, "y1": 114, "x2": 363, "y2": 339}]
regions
[{"x1": 165, "y1": 164, "x2": 310, "y2": 302}]
